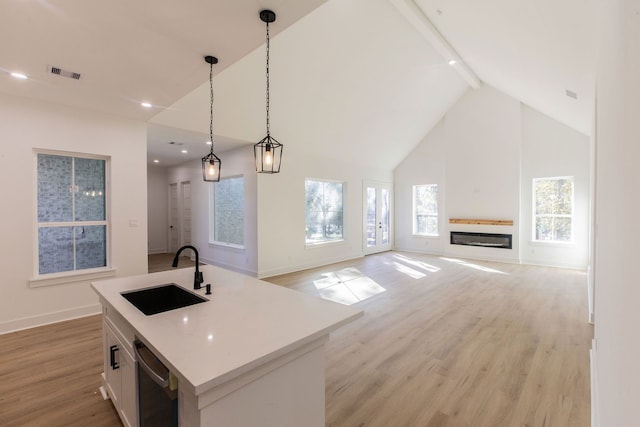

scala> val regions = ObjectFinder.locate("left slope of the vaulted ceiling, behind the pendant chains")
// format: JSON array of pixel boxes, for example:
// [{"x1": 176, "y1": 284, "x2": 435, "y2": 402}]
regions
[{"x1": 152, "y1": 0, "x2": 468, "y2": 171}]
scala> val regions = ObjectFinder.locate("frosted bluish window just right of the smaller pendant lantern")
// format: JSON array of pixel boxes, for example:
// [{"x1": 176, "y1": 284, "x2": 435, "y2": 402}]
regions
[{"x1": 212, "y1": 176, "x2": 244, "y2": 247}]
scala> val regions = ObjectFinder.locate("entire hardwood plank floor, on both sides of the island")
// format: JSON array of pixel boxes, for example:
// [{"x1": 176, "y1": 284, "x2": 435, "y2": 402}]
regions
[{"x1": 0, "y1": 252, "x2": 593, "y2": 427}]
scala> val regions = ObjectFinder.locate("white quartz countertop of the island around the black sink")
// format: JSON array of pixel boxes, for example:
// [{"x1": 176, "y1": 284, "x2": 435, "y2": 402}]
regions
[{"x1": 91, "y1": 265, "x2": 363, "y2": 394}]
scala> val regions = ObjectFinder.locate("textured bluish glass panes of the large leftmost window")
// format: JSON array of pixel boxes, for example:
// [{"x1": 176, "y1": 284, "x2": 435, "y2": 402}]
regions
[{"x1": 36, "y1": 153, "x2": 108, "y2": 275}]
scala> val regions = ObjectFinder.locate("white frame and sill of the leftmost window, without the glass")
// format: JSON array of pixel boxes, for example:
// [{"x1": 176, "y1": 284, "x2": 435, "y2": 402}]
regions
[{"x1": 28, "y1": 149, "x2": 116, "y2": 288}]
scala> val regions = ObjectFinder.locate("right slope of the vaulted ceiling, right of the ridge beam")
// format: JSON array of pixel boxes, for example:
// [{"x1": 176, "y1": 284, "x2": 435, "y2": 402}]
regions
[{"x1": 415, "y1": 0, "x2": 596, "y2": 134}]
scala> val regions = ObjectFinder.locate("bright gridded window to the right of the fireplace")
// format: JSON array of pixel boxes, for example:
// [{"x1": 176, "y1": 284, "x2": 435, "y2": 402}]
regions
[{"x1": 533, "y1": 177, "x2": 573, "y2": 242}]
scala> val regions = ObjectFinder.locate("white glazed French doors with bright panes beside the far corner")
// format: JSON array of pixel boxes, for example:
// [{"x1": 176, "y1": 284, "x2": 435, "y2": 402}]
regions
[{"x1": 363, "y1": 181, "x2": 393, "y2": 255}]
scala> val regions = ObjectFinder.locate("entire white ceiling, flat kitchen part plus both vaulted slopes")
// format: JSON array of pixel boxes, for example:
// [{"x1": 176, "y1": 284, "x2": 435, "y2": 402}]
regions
[{"x1": 0, "y1": 0, "x2": 595, "y2": 170}]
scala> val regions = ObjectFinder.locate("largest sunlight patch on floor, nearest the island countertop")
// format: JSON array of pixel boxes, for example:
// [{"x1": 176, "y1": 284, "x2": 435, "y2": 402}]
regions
[{"x1": 313, "y1": 268, "x2": 386, "y2": 305}]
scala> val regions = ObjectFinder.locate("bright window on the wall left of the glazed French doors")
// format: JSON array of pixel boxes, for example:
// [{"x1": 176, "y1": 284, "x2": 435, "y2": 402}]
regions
[{"x1": 304, "y1": 179, "x2": 344, "y2": 244}]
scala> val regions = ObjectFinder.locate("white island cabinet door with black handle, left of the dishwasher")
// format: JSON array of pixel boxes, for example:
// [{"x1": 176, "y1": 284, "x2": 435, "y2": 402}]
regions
[{"x1": 103, "y1": 307, "x2": 138, "y2": 427}]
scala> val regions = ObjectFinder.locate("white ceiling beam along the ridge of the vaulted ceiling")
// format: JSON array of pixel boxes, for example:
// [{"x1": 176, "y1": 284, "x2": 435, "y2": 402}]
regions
[{"x1": 389, "y1": 0, "x2": 482, "y2": 89}]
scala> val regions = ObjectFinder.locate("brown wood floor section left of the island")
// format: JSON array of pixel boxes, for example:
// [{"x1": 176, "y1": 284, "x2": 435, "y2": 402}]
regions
[{"x1": 0, "y1": 315, "x2": 121, "y2": 427}]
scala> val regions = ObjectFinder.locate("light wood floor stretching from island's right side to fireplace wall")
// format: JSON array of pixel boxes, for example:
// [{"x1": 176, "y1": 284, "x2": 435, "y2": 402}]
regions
[{"x1": 267, "y1": 252, "x2": 593, "y2": 427}]
